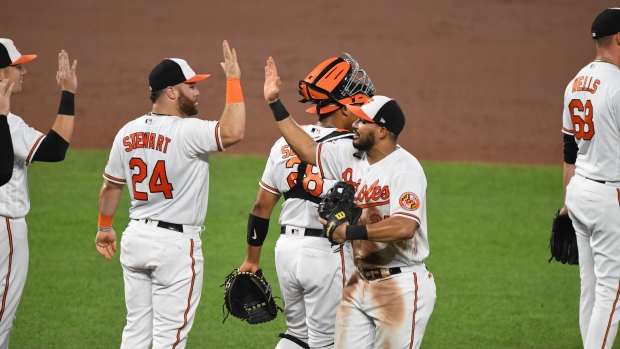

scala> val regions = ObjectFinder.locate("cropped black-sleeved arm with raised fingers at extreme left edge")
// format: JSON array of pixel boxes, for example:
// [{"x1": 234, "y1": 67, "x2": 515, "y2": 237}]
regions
[{"x1": 0, "y1": 79, "x2": 15, "y2": 187}]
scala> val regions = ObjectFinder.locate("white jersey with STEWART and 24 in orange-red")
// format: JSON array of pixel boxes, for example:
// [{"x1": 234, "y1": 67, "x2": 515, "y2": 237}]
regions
[{"x1": 104, "y1": 113, "x2": 224, "y2": 226}]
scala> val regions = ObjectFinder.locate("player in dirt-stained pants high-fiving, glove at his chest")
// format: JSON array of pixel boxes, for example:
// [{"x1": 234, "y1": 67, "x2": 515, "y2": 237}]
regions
[{"x1": 264, "y1": 57, "x2": 436, "y2": 349}]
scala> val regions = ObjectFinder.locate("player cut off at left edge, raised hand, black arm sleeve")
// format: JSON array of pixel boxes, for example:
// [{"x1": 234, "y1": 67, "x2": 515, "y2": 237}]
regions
[{"x1": 0, "y1": 39, "x2": 77, "y2": 348}]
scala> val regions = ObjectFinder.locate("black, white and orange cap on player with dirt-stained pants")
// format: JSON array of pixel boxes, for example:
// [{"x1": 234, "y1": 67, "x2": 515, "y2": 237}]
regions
[{"x1": 347, "y1": 96, "x2": 405, "y2": 136}]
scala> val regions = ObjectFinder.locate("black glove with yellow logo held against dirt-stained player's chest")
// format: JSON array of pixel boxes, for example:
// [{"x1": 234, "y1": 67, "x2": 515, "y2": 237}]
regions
[{"x1": 319, "y1": 182, "x2": 362, "y2": 243}]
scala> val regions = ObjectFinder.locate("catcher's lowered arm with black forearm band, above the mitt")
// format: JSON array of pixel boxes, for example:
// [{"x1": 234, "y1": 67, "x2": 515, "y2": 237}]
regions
[{"x1": 239, "y1": 188, "x2": 280, "y2": 274}]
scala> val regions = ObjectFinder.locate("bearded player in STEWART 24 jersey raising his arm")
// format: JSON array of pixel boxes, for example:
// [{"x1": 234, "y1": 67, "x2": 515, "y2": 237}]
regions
[{"x1": 96, "y1": 41, "x2": 245, "y2": 349}]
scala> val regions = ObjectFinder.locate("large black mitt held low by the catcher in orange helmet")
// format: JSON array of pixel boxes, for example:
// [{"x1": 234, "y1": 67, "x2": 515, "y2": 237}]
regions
[{"x1": 220, "y1": 269, "x2": 282, "y2": 324}]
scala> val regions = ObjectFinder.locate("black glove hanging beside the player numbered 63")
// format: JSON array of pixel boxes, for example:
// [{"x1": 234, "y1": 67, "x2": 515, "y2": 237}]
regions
[{"x1": 549, "y1": 210, "x2": 579, "y2": 264}]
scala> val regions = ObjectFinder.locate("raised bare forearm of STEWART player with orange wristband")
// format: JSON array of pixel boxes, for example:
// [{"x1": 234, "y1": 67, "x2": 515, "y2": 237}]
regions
[{"x1": 220, "y1": 40, "x2": 245, "y2": 148}]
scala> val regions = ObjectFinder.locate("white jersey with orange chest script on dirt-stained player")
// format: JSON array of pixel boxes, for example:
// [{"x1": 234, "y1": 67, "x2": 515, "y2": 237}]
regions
[{"x1": 316, "y1": 143, "x2": 429, "y2": 268}]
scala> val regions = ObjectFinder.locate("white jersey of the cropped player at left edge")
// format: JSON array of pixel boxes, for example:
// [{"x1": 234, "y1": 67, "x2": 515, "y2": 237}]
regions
[{"x1": 0, "y1": 112, "x2": 45, "y2": 218}]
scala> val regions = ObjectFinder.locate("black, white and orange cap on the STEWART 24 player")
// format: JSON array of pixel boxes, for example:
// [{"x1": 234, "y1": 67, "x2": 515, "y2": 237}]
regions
[{"x1": 149, "y1": 58, "x2": 211, "y2": 91}]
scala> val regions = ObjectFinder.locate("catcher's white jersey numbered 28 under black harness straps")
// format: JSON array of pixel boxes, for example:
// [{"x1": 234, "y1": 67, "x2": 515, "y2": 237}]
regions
[{"x1": 259, "y1": 125, "x2": 351, "y2": 229}]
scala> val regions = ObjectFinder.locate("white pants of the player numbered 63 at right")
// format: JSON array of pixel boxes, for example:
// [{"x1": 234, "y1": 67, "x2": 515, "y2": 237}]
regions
[{"x1": 566, "y1": 174, "x2": 620, "y2": 349}]
